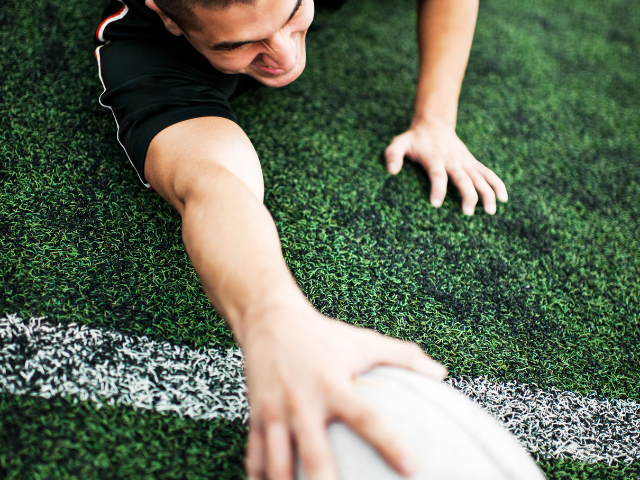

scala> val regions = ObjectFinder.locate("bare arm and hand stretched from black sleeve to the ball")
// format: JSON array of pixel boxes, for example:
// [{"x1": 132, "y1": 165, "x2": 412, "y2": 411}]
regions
[{"x1": 145, "y1": 118, "x2": 446, "y2": 480}]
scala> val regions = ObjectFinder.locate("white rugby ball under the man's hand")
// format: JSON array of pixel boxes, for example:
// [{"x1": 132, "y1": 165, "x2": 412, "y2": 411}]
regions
[{"x1": 297, "y1": 367, "x2": 545, "y2": 480}]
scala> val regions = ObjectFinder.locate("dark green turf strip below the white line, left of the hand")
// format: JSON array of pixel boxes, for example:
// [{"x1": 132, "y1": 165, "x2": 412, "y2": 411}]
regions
[{"x1": 0, "y1": 395, "x2": 246, "y2": 479}]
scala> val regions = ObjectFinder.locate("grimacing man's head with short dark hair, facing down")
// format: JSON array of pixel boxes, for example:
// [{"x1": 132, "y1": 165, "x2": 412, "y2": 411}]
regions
[{"x1": 146, "y1": 0, "x2": 314, "y2": 87}]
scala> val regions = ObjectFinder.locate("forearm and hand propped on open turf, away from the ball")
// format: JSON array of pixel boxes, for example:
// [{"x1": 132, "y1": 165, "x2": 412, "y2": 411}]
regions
[{"x1": 385, "y1": 0, "x2": 508, "y2": 215}]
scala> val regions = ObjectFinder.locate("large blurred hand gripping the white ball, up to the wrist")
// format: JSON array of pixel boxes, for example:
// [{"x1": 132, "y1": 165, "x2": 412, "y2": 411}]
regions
[{"x1": 241, "y1": 302, "x2": 447, "y2": 480}]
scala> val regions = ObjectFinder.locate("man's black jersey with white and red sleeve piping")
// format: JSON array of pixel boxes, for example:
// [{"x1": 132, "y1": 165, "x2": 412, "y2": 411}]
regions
[{"x1": 95, "y1": 0, "x2": 257, "y2": 187}]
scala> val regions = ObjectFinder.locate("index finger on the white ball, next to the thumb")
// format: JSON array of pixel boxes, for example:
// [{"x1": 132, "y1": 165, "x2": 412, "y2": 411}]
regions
[{"x1": 335, "y1": 391, "x2": 416, "y2": 475}]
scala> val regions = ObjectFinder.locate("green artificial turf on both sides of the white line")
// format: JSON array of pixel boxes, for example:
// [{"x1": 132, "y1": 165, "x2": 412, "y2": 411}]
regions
[{"x1": 0, "y1": 0, "x2": 640, "y2": 479}]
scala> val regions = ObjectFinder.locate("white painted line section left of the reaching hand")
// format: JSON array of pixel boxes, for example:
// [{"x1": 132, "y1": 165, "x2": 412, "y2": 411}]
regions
[{"x1": 0, "y1": 315, "x2": 249, "y2": 421}]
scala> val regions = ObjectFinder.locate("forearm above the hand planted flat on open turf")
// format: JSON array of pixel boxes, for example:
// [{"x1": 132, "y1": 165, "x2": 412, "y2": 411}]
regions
[{"x1": 413, "y1": 0, "x2": 478, "y2": 126}]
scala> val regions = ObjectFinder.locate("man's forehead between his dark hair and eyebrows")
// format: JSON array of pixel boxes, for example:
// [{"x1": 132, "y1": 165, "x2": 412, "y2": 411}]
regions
[{"x1": 193, "y1": 0, "x2": 302, "y2": 46}]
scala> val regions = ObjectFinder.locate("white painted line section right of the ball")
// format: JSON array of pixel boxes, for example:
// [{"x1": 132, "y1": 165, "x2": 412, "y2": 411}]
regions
[{"x1": 446, "y1": 377, "x2": 640, "y2": 465}]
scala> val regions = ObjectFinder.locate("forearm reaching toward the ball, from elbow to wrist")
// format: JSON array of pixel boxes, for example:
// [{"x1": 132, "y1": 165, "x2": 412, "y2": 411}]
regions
[{"x1": 182, "y1": 168, "x2": 306, "y2": 345}]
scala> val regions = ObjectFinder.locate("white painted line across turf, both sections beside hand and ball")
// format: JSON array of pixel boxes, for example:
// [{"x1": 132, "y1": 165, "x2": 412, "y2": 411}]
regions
[{"x1": 0, "y1": 315, "x2": 640, "y2": 463}]
